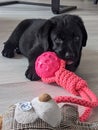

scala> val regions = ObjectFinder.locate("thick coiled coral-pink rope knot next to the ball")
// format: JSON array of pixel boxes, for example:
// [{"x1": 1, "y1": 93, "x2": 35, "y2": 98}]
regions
[{"x1": 55, "y1": 68, "x2": 87, "y2": 96}]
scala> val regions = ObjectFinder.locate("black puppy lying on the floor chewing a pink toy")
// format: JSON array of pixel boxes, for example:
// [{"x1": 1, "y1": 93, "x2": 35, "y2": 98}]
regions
[{"x1": 2, "y1": 15, "x2": 87, "y2": 80}]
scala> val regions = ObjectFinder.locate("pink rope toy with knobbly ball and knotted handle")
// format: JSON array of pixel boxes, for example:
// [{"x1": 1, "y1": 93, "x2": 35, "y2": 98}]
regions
[{"x1": 35, "y1": 52, "x2": 98, "y2": 121}]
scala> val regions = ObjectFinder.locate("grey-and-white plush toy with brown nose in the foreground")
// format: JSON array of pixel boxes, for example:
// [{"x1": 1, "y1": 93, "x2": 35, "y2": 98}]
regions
[{"x1": 0, "y1": 93, "x2": 98, "y2": 130}]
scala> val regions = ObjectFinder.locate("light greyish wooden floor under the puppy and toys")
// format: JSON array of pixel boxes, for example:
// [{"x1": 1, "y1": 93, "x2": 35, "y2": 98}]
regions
[{"x1": 0, "y1": 0, "x2": 98, "y2": 121}]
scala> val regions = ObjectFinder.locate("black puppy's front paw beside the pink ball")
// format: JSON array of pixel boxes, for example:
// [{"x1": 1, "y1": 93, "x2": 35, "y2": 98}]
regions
[{"x1": 25, "y1": 68, "x2": 40, "y2": 81}]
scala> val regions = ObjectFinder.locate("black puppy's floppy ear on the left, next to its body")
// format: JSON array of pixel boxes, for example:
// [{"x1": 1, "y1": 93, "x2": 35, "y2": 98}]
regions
[{"x1": 38, "y1": 20, "x2": 54, "y2": 51}]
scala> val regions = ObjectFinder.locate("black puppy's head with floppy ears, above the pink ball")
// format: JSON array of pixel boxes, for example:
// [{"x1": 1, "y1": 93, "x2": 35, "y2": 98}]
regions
[{"x1": 37, "y1": 15, "x2": 87, "y2": 68}]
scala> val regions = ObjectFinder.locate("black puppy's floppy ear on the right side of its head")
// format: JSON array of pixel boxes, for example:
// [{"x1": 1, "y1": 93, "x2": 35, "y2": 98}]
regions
[{"x1": 73, "y1": 16, "x2": 87, "y2": 47}]
